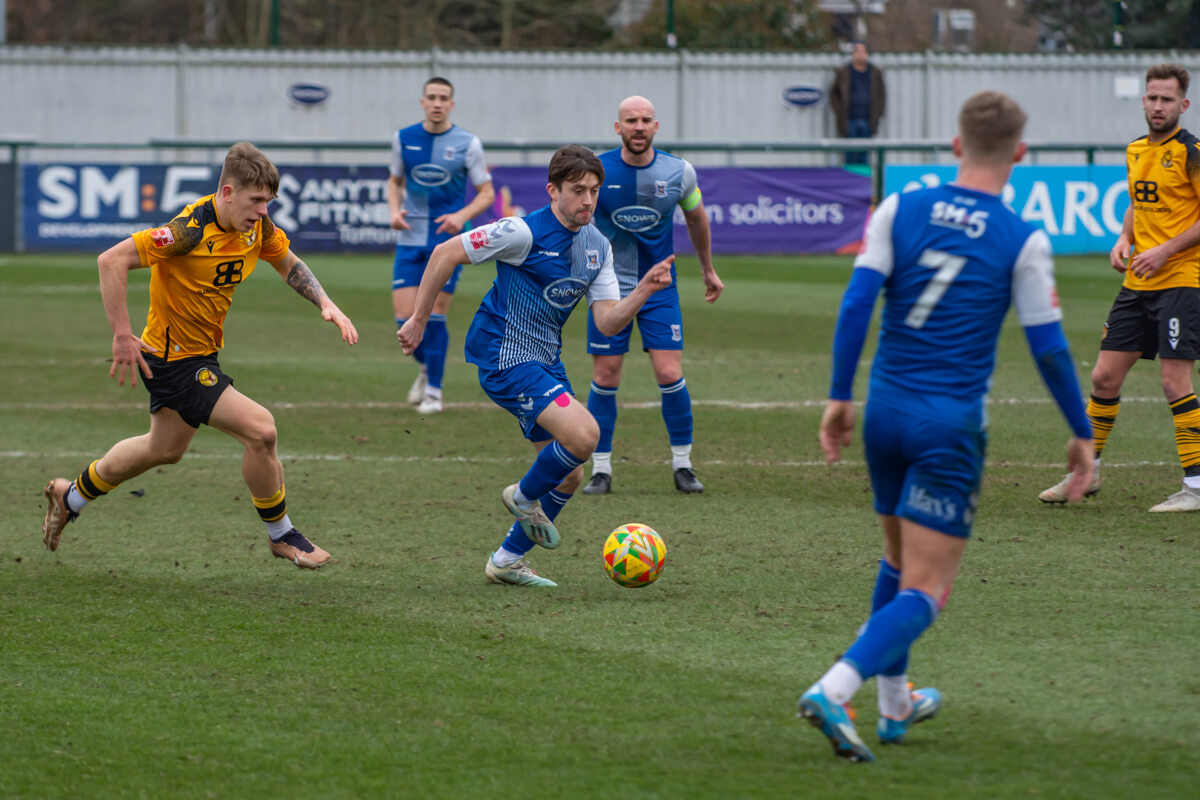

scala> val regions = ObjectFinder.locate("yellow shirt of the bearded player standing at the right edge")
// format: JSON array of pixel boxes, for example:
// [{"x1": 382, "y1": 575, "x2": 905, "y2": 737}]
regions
[{"x1": 1123, "y1": 128, "x2": 1200, "y2": 291}]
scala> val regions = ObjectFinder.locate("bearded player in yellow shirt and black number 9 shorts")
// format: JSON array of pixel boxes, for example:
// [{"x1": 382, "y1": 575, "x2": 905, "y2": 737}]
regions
[{"x1": 1038, "y1": 64, "x2": 1200, "y2": 512}]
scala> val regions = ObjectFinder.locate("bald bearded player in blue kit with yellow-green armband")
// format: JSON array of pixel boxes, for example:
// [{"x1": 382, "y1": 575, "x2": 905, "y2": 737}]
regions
[{"x1": 583, "y1": 95, "x2": 725, "y2": 494}]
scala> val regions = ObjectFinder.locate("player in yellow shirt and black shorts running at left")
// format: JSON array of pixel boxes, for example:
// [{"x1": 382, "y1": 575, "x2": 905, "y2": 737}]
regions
[{"x1": 42, "y1": 142, "x2": 359, "y2": 570}]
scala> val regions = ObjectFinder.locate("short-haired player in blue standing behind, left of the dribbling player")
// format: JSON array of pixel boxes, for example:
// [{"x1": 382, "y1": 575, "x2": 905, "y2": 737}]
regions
[{"x1": 388, "y1": 78, "x2": 496, "y2": 414}]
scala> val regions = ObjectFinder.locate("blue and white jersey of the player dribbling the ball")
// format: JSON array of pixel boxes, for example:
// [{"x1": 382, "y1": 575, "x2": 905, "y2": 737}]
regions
[{"x1": 461, "y1": 205, "x2": 619, "y2": 371}]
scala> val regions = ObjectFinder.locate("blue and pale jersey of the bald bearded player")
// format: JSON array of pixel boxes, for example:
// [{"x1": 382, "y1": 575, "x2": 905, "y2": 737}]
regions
[{"x1": 595, "y1": 148, "x2": 700, "y2": 297}]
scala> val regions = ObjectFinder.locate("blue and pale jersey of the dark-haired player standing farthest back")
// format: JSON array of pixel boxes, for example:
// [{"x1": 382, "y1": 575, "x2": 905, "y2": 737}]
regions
[{"x1": 389, "y1": 122, "x2": 492, "y2": 247}]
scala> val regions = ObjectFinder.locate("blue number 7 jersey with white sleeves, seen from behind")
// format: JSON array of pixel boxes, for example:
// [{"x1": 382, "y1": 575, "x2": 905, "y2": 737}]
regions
[{"x1": 854, "y1": 184, "x2": 1062, "y2": 427}]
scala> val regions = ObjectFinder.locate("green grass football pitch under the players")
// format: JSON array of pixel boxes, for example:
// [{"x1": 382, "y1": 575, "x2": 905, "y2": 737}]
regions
[{"x1": 0, "y1": 255, "x2": 1200, "y2": 799}]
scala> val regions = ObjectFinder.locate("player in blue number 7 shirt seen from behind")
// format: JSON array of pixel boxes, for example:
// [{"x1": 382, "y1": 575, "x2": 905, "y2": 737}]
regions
[{"x1": 799, "y1": 91, "x2": 1093, "y2": 762}]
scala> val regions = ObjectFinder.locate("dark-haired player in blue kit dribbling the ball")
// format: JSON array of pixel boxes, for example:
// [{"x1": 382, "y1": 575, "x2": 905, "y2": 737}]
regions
[{"x1": 396, "y1": 145, "x2": 674, "y2": 587}]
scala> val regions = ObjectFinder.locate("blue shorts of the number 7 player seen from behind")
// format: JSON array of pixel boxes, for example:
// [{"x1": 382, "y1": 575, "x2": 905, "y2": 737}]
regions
[{"x1": 863, "y1": 402, "x2": 988, "y2": 539}]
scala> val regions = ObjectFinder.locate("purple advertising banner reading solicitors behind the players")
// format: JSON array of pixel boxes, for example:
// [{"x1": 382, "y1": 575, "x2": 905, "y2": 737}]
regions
[{"x1": 492, "y1": 167, "x2": 871, "y2": 254}]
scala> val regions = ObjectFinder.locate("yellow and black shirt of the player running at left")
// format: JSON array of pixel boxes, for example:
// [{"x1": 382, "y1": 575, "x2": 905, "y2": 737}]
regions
[{"x1": 133, "y1": 194, "x2": 289, "y2": 361}]
